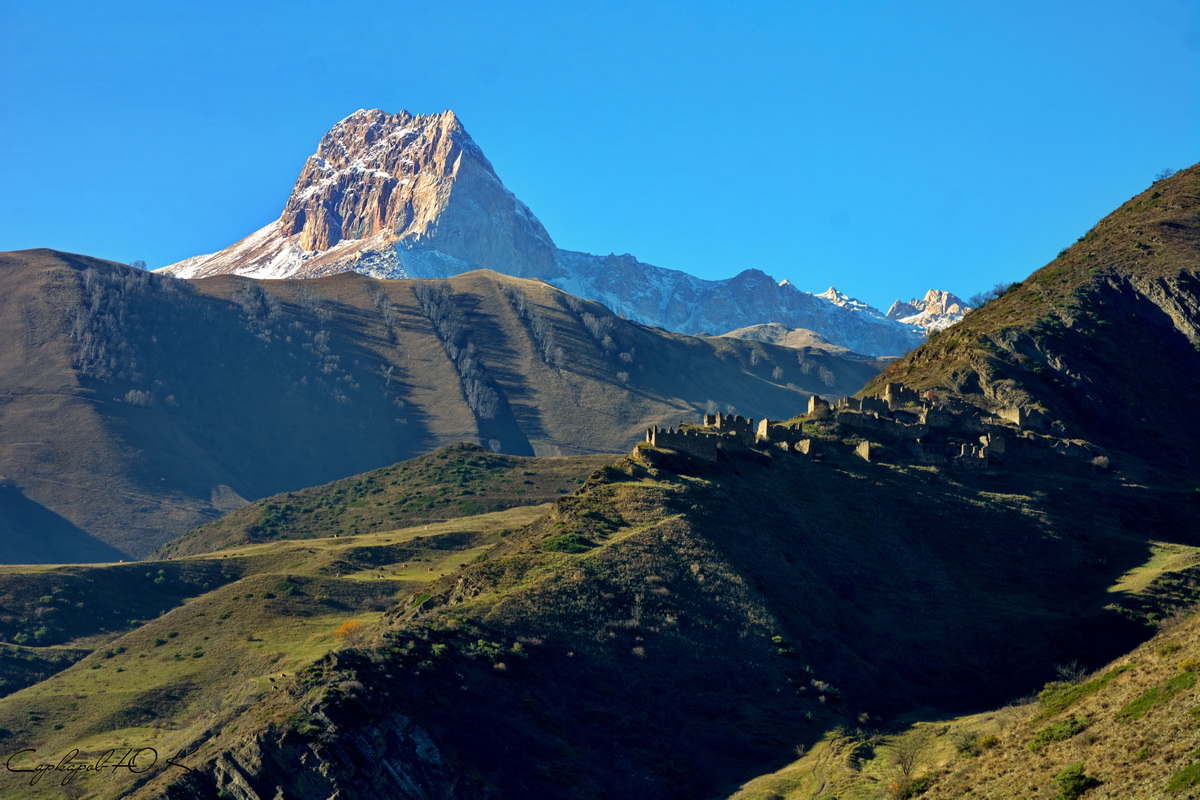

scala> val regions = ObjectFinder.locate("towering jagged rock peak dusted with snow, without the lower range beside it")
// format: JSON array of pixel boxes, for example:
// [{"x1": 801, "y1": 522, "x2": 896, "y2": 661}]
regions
[{"x1": 164, "y1": 110, "x2": 556, "y2": 278}]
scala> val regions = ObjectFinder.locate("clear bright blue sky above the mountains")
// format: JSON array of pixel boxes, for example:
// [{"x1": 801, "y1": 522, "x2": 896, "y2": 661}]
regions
[{"x1": 0, "y1": 0, "x2": 1200, "y2": 306}]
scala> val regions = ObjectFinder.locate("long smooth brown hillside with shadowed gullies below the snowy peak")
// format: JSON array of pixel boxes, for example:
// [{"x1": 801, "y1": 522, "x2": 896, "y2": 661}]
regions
[{"x1": 0, "y1": 251, "x2": 871, "y2": 563}]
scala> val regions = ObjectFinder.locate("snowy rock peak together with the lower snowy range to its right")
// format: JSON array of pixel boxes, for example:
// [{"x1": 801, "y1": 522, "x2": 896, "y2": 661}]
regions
[{"x1": 161, "y1": 110, "x2": 925, "y2": 355}]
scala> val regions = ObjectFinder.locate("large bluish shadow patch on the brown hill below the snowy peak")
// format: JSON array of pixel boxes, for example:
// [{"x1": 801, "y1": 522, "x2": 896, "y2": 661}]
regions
[{"x1": 94, "y1": 275, "x2": 433, "y2": 533}]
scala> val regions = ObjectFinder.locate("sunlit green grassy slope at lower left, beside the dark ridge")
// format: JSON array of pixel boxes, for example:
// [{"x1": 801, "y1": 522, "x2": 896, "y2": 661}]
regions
[{"x1": 0, "y1": 506, "x2": 546, "y2": 798}]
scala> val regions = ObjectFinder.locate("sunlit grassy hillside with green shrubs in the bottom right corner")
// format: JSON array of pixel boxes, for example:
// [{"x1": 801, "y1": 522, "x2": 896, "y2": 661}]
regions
[{"x1": 731, "y1": 599, "x2": 1200, "y2": 800}]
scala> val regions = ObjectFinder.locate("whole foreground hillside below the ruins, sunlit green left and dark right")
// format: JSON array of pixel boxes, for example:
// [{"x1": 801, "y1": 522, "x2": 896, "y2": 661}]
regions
[{"x1": 0, "y1": 431, "x2": 1180, "y2": 798}]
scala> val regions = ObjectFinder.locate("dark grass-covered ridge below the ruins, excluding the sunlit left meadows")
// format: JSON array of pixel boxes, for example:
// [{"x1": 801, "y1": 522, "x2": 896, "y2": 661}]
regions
[{"x1": 68, "y1": 431, "x2": 1188, "y2": 798}]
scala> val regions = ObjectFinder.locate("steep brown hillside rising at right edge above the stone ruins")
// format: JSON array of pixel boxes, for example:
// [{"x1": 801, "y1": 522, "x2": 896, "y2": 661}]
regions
[{"x1": 866, "y1": 166, "x2": 1200, "y2": 473}]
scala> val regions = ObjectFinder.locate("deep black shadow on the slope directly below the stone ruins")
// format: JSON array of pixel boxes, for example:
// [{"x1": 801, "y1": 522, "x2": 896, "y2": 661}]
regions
[{"x1": 696, "y1": 459, "x2": 1180, "y2": 716}]
